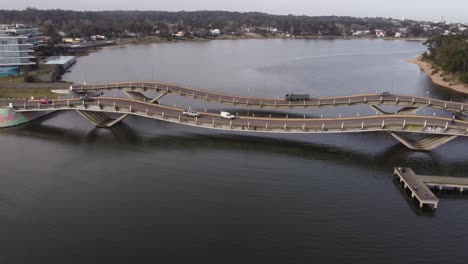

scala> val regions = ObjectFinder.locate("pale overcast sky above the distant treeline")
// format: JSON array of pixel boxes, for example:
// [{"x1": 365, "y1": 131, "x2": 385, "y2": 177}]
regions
[{"x1": 0, "y1": 0, "x2": 468, "y2": 23}]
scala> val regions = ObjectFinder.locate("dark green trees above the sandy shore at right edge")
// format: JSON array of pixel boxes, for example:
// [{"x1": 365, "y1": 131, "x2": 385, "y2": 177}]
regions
[{"x1": 423, "y1": 35, "x2": 468, "y2": 83}]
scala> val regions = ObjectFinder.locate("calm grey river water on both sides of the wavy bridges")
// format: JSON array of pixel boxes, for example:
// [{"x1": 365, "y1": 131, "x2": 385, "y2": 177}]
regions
[{"x1": 0, "y1": 40, "x2": 468, "y2": 263}]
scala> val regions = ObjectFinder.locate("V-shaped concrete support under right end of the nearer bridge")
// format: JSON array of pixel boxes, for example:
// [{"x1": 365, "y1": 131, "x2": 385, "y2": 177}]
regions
[{"x1": 390, "y1": 132, "x2": 458, "y2": 151}]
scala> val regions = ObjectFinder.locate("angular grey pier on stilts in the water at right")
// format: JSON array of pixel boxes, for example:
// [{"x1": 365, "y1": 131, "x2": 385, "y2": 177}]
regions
[{"x1": 394, "y1": 167, "x2": 468, "y2": 208}]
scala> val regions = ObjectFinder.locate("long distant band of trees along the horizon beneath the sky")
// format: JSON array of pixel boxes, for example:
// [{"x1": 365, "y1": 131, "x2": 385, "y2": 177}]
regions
[{"x1": 0, "y1": 8, "x2": 436, "y2": 37}]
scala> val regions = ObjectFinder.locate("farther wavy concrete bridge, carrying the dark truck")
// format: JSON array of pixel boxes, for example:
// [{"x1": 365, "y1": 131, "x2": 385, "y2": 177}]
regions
[{"x1": 66, "y1": 81, "x2": 468, "y2": 114}]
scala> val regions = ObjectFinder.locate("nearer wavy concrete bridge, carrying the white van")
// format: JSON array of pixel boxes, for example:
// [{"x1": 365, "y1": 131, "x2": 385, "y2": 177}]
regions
[{"x1": 0, "y1": 97, "x2": 468, "y2": 150}]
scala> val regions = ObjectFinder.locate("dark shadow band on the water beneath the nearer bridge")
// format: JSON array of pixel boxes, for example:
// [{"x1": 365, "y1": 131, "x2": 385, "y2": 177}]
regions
[{"x1": 2, "y1": 114, "x2": 468, "y2": 175}]
